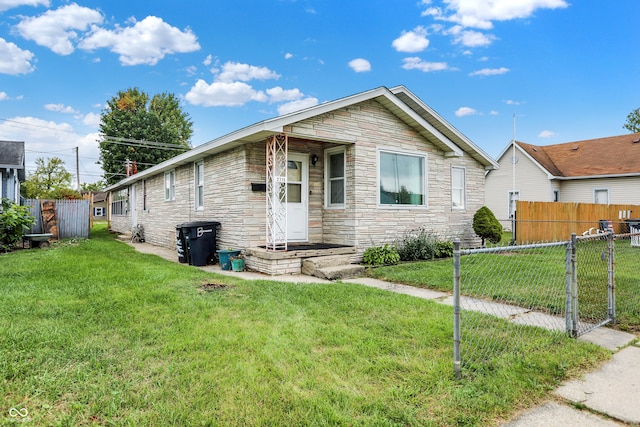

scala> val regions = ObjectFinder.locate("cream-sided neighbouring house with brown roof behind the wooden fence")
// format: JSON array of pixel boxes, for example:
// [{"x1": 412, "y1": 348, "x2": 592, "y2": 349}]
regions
[{"x1": 486, "y1": 133, "x2": 640, "y2": 228}]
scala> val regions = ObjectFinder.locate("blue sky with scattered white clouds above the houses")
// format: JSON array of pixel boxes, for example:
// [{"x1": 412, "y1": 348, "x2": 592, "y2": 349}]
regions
[{"x1": 0, "y1": 0, "x2": 640, "y2": 182}]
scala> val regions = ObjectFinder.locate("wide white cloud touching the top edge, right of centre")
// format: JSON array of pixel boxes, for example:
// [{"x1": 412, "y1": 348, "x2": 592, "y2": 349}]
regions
[{"x1": 422, "y1": 0, "x2": 569, "y2": 30}]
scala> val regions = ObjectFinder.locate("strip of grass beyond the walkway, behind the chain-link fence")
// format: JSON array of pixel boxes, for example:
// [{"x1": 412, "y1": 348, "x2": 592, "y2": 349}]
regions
[{"x1": 368, "y1": 240, "x2": 640, "y2": 332}]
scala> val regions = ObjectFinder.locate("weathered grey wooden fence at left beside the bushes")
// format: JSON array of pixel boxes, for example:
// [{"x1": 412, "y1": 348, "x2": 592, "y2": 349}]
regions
[{"x1": 23, "y1": 199, "x2": 91, "y2": 239}]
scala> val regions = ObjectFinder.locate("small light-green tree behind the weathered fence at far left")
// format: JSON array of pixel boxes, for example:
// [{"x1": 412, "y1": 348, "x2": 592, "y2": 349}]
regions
[{"x1": 20, "y1": 157, "x2": 81, "y2": 199}]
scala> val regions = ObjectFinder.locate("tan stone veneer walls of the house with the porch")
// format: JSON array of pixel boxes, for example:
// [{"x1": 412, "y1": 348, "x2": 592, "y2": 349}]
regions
[{"x1": 111, "y1": 100, "x2": 484, "y2": 271}]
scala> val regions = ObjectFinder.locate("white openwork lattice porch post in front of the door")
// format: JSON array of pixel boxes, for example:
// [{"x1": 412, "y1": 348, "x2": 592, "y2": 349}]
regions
[{"x1": 266, "y1": 133, "x2": 289, "y2": 251}]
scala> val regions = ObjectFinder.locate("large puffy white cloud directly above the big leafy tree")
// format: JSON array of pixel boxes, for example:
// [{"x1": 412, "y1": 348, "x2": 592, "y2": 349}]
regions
[{"x1": 78, "y1": 16, "x2": 200, "y2": 65}]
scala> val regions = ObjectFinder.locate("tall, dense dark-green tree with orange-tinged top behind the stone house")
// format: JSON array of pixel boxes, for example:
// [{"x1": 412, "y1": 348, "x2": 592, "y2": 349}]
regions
[{"x1": 100, "y1": 88, "x2": 193, "y2": 184}]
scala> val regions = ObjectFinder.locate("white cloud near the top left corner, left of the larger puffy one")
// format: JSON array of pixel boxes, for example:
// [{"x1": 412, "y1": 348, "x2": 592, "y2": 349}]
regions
[{"x1": 16, "y1": 3, "x2": 103, "y2": 55}]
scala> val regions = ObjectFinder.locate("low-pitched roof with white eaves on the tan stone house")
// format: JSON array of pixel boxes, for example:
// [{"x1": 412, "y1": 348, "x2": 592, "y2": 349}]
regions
[{"x1": 105, "y1": 86, "x2": 499, "y2": 191}]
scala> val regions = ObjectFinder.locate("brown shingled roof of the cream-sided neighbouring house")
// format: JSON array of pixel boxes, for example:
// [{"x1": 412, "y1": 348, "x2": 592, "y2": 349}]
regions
[{"x1": 516, "y1": 133, "x2": 640, "y2": 179}]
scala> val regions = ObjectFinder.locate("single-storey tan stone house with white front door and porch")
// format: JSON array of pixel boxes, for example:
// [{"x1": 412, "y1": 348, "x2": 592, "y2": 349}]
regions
[{"x1": 106, "y1": 86, "x2": 497, "y2": 274}]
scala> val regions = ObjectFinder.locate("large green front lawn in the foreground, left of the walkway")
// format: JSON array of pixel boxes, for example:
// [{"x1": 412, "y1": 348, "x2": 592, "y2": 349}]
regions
[{"x1": 0, "y1": 229, "x2": 608, "y2": 426}]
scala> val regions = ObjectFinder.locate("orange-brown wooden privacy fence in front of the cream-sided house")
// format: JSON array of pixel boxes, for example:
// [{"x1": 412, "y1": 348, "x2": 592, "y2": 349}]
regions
[{"x1": 514, "y1": 200, "x2": 640, "y2": 244}]
